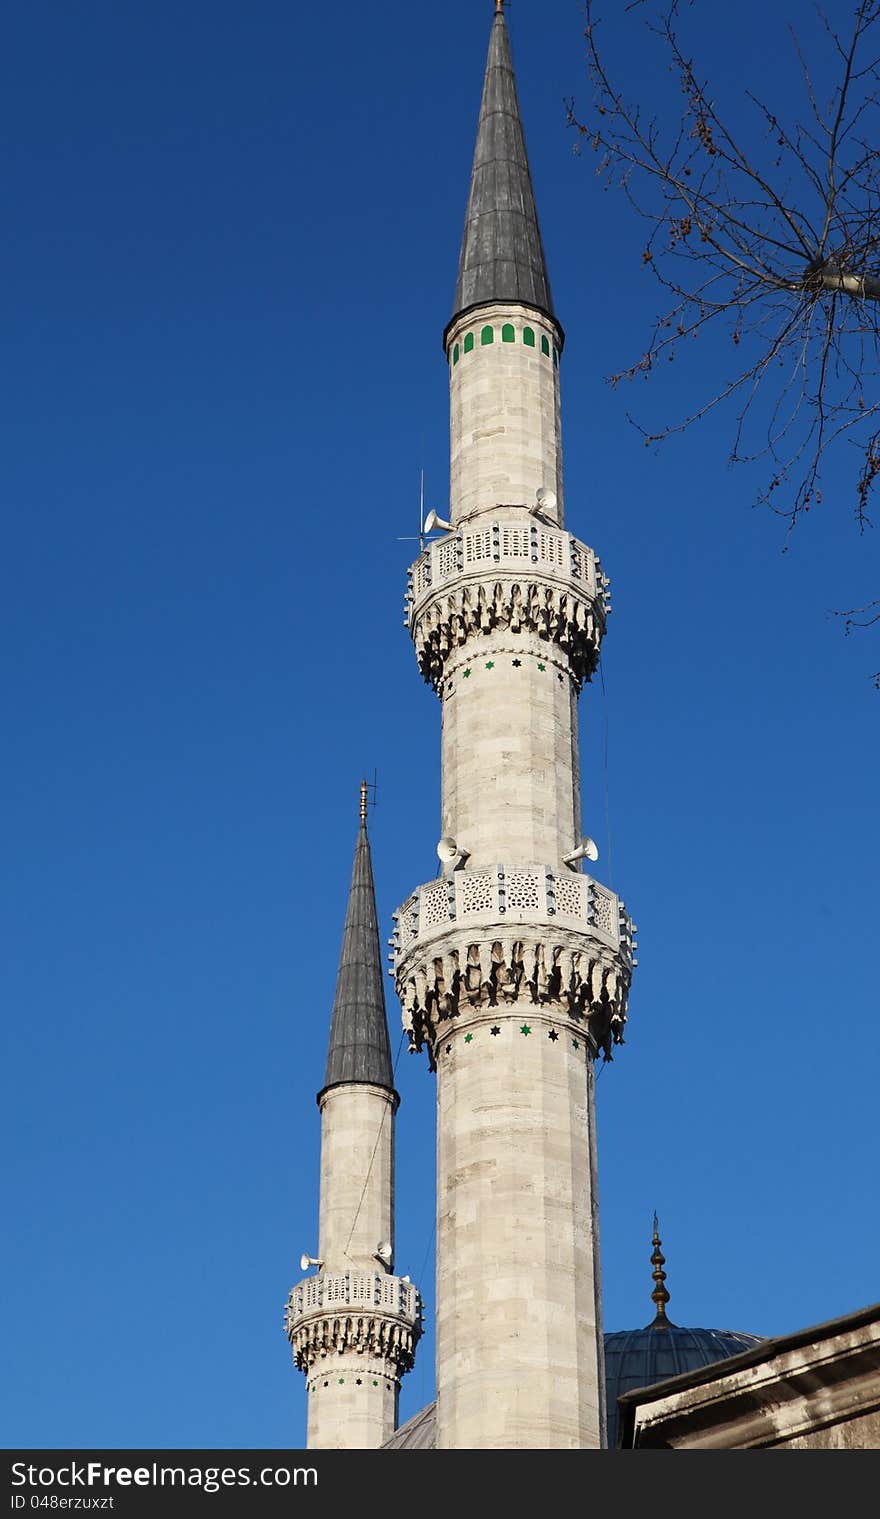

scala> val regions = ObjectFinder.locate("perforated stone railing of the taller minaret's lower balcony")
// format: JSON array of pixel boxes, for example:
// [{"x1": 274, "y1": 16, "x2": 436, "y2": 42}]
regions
[{"x1": 392, "y1": 864, "x2": 635, "y2": 958}]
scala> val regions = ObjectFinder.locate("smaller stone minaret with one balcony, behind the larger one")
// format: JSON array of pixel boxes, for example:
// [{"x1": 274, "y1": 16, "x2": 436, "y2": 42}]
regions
[{"x1": 284, "y1": 782, "x2": 421, "y2": 1451}]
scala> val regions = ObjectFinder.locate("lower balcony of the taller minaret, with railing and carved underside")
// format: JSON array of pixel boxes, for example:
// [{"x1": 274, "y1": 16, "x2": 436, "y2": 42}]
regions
[{"x1": 389, "y1": 864, "x2": 637, "y2": 1062}]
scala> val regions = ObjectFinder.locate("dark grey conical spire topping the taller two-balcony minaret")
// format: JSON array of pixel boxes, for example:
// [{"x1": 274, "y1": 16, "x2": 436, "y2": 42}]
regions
[{"x1": 453, "y1": 5, "x2": 553, "y2": 321}]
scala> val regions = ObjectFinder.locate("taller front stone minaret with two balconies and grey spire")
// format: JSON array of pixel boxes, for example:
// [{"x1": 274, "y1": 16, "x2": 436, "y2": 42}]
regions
[{"x1": 394, "y1": 0, "x2": 634, "y2": 1449}]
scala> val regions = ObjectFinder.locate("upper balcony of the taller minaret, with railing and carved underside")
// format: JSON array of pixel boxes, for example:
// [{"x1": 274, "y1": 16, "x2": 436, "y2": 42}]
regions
[{"x1": 404, "y1": 519, "x2": 611, "y2": 690}]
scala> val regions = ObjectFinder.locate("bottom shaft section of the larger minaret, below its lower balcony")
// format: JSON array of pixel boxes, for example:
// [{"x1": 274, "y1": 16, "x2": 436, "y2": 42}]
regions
[{"x1": 436, "y1": 1001, "x2": 603, "y2": 1449}]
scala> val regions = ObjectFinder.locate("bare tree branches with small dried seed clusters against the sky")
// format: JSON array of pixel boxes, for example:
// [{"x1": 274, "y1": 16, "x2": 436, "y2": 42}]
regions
[{"x1": 568, "y1": 0, "x2": 880, "y2": 680}]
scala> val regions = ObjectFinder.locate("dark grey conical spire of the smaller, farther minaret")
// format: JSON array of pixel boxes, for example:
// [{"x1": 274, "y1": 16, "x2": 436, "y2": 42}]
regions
[{"x1": 324, "y1": 782, "x2": 394, "y2": 1091}]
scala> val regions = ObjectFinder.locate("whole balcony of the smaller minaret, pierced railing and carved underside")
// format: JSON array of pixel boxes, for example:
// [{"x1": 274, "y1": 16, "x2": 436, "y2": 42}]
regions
[{"x1": 284, "y1": 1271, "x2": 423, "y2": 1373}]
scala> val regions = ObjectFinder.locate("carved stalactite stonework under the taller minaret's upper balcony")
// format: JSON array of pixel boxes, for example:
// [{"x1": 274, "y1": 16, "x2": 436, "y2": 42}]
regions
[{"x1": 410, "y1": 579, "x2": 605, "y2": 691}]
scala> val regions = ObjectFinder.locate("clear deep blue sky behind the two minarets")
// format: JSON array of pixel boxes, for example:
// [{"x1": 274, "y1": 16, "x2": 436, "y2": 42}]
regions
[{"x1": 0, "y1": 0, "x2": 880, "y2": 1448}]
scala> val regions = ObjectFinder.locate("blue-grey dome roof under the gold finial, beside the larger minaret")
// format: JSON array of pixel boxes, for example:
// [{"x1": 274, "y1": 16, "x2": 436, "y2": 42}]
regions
[{"x1": 605, "y1": 1320, "x2": 761, "y2": 1449}]
